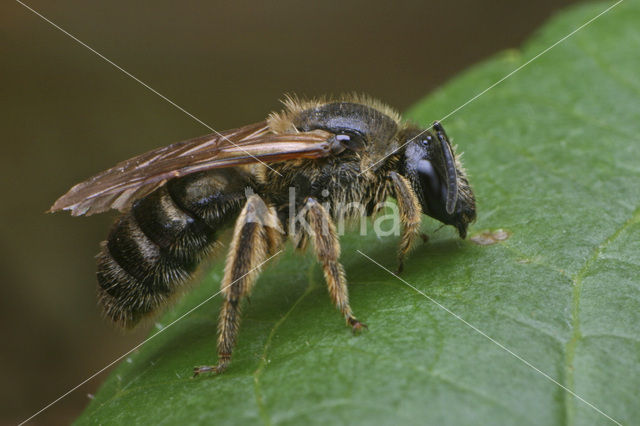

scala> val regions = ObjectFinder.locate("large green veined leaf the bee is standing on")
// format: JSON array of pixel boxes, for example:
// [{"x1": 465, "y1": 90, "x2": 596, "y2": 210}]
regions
[{"x1": 78, "y1": 1, "x2": 640, "y2": 425}]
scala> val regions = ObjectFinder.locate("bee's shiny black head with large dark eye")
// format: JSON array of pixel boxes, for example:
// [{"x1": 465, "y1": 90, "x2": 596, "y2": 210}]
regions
[{"x1": 401, "y1": 122, "x2": 476, "y2": 238}]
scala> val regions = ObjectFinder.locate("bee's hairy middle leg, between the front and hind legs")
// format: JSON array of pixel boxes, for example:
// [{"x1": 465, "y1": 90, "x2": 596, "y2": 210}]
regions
[{"x1": 305, "y1": 198, "x2": 367, "y2": 333}]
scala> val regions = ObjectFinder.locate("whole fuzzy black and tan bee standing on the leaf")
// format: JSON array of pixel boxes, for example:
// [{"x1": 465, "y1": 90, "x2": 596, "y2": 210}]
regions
[{"x1": 50, "y1": 95, "x2": 476, "y2": 375}]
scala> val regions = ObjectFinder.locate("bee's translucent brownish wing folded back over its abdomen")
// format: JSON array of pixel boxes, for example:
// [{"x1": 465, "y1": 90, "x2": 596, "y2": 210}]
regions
[{"x1": 49, "y1": 121, "x2": 331, "y2": 216}]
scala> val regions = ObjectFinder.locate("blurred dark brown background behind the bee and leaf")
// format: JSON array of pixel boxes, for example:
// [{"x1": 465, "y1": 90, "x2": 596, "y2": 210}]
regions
[{"x1": 0, "y1": 0, "x2": 584, "y2": 424}]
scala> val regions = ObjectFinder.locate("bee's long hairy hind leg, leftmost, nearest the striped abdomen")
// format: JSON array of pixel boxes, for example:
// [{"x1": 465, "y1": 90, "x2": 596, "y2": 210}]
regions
[{"x1": 193, "y1": 194, "x2": 282, "y2": 377}]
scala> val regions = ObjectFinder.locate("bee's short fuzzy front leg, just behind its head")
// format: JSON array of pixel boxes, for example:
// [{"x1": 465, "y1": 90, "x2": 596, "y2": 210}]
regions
[{"x1": 389, "y1": 172, "x2": 428, "y2": 274}]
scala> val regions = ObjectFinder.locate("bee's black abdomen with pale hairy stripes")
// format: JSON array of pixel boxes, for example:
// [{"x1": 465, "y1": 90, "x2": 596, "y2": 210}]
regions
[{"x1": 97, "y1": 169, "x2": 251, "y2": 328}]
